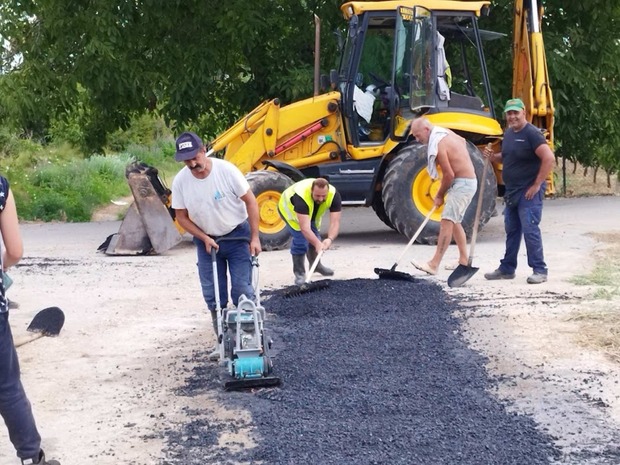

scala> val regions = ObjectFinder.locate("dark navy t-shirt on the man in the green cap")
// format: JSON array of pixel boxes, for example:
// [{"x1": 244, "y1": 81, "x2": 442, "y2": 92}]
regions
[{"x1": 502, "y1": 123, "x2": 547, "y2": 191}]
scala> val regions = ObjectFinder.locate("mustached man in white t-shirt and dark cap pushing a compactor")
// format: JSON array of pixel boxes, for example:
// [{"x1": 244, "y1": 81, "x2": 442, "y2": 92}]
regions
[{"x1": 172, "y1": 132, "x2": 261, "y2": 360}]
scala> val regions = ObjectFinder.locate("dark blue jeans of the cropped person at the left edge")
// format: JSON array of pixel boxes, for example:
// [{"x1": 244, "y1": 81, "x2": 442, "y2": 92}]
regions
[{"x1": 0, "y1": 312, "x2": 41, "y2": 459}]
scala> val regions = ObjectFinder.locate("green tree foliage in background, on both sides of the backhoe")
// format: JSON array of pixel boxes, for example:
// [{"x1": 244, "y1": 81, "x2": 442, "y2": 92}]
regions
[{"x1": 0, "y1": 0, "x2": 620, "y2": 178}]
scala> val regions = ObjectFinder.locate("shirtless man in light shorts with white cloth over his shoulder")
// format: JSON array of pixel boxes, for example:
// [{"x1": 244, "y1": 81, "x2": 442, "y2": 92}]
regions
[{"x1": 411, "y1": 117, "x2": 477, "y2": 275}]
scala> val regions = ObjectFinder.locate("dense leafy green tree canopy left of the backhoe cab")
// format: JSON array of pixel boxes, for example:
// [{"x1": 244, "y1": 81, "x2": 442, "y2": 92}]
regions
[{"x1": 0, "y1": 0, "x2": 338, "y2": 149}]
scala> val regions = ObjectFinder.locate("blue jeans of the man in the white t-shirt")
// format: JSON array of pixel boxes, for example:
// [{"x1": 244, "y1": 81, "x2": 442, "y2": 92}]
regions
[{"x1": 194, "y1": 221, "x2": 255, "y2": 334}]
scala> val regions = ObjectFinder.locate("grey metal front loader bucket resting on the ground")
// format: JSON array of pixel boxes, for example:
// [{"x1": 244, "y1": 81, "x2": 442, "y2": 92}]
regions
[{"x1": 100, "y1": 163, "x2": 182, "y2": 255}]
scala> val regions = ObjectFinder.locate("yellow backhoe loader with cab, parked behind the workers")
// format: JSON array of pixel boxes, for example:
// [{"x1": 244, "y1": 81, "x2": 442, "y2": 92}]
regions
[{"x1": 105, "y1": 0, "x2": 554, "y2": 254}]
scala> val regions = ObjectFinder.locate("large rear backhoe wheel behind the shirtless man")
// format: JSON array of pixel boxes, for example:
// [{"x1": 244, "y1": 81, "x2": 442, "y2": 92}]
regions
[{"x1": 383, "y1": 141, "x2": 497, "y2": 244}]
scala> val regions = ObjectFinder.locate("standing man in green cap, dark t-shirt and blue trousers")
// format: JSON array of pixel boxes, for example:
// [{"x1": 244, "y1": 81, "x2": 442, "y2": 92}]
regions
[{"x1": 484, "y1": 98, "x2": 555, "y2": 284}]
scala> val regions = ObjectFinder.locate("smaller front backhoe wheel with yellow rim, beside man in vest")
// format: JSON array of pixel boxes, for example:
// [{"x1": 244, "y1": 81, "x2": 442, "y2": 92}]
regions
[{"x1": 246, "y1": 171, "x2": 293, "y2": 251}]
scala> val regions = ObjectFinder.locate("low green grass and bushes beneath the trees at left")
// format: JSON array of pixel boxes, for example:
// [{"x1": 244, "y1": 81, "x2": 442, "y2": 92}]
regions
[{"x1": 0, "y1": 117, "x2": 179, "y2": 222}]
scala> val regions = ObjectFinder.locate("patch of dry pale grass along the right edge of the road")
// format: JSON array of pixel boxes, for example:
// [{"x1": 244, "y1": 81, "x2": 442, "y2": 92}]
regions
[{"x1": 571, "y1": 231, "x2": 620, "y2": 361}]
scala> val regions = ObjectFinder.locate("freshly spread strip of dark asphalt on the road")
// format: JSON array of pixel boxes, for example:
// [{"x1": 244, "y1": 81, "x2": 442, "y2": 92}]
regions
[{"x1": 164, "y1": 279, "x2": 558, "y2": 465}]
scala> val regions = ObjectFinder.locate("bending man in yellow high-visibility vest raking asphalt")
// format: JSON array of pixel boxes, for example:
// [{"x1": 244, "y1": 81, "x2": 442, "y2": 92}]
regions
[{"x1": 278, "y1": 178, "x2": 342, "y2": 285}]
